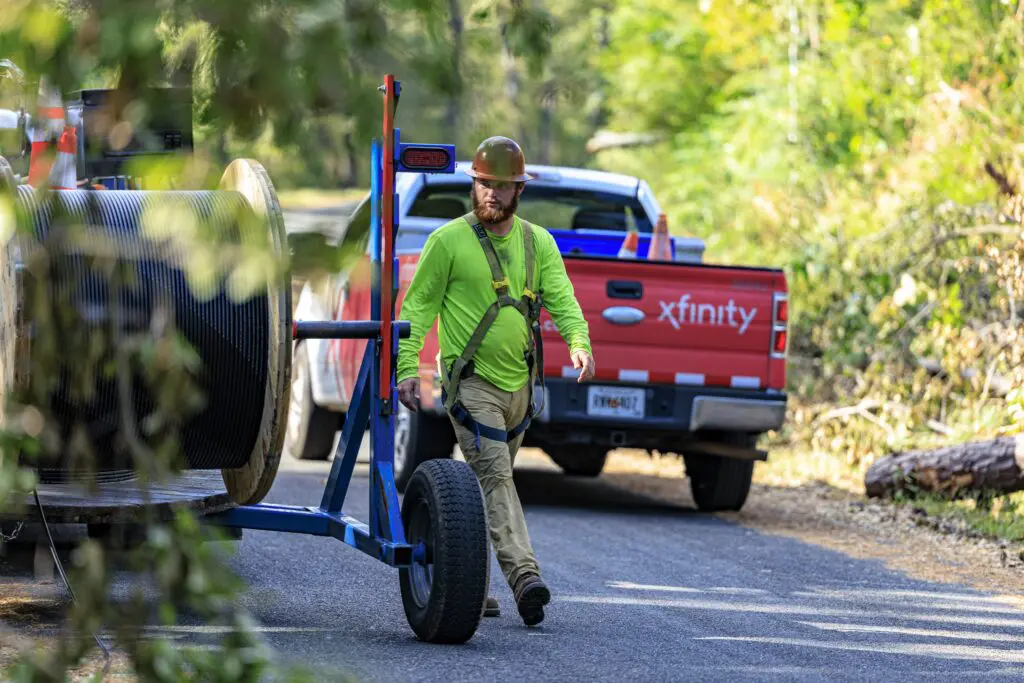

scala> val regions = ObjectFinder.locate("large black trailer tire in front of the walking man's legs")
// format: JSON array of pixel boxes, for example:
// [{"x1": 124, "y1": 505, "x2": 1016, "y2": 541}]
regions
[{"x1": 398, "y1": 460, "x2": 487, "y2": 643}]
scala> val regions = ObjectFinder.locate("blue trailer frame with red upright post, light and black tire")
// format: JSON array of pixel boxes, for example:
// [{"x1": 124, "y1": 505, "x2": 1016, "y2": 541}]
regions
[{"x1": 7, "y1": 75, "x2": 489, "y2": 643}]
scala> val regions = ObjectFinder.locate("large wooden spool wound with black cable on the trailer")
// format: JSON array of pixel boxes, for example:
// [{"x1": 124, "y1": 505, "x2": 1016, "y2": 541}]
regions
[{"x1": 0, "y1": 160, "x2": 292, "y2": 505}]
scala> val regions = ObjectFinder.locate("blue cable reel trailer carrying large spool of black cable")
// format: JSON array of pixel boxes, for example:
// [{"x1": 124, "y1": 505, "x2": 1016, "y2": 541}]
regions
[{"x1": 0, "y1": 75, "x2": 488, "y2": 643}]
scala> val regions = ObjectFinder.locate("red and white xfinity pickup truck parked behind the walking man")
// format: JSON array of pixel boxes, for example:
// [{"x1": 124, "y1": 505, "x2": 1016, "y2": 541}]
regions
[{"x1": 287, "y1": 165, "x2": 787, "y2": 511}]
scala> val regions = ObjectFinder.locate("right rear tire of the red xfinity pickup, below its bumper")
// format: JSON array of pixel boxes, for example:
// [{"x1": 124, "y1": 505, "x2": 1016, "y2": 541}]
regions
[{"x1": 683, "y1": 433, "x2": 757, "y2": 512}]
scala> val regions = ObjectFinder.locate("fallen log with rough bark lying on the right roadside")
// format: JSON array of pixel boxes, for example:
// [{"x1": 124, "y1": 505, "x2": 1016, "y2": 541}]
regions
[{"x1": 864, "y1": 435, "x2": 1024, "y2": 498}]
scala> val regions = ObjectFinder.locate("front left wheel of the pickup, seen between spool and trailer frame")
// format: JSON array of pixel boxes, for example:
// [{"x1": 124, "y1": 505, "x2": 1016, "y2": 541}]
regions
[{"x1": 285, "y1": 342, "x2": 343, "y2": 460}]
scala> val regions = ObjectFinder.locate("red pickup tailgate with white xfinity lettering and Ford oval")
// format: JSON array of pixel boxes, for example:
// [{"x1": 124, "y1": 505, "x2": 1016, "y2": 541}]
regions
[{"x1": 542, "y1": 256, "x2": 785, "y2": 389}]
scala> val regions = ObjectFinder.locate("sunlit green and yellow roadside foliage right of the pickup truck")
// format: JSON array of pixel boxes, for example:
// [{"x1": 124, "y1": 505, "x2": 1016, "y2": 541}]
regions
[{"x1": 598, "y1": 0, "x2": 1024, "y2": 479}]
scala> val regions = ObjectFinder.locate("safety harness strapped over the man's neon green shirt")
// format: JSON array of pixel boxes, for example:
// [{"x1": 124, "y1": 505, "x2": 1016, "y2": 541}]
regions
[{"x1": 441, "y1": 213, "x2": 544, "y2": 451}]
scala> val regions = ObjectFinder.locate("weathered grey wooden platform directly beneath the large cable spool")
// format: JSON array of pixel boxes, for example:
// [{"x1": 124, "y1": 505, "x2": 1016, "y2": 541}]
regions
[{"x1": 0, "y1": 470, "x2": 234, "y2": 523}]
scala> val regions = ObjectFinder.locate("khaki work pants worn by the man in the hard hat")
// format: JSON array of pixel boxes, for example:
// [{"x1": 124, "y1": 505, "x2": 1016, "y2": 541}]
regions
[{"x1": 450, "y1": 375, "x2": 541, "y2": 590}]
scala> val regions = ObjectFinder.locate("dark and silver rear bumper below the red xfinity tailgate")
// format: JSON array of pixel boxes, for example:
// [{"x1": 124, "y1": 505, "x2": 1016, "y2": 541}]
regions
[{"x1": 526, "y1": 379, "x2": 786, "y2": 449}]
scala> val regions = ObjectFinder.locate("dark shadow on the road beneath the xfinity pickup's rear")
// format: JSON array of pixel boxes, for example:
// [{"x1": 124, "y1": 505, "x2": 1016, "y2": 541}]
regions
[{"x1": 514, "y1": 469, "x2": 697, "y2": 514}]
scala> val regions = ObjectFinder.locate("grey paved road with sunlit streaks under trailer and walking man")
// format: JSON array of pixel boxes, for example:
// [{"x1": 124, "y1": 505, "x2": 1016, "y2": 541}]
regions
[{"x1": 218, "y1": 448, "x2": 1024, "y2": 683}]
